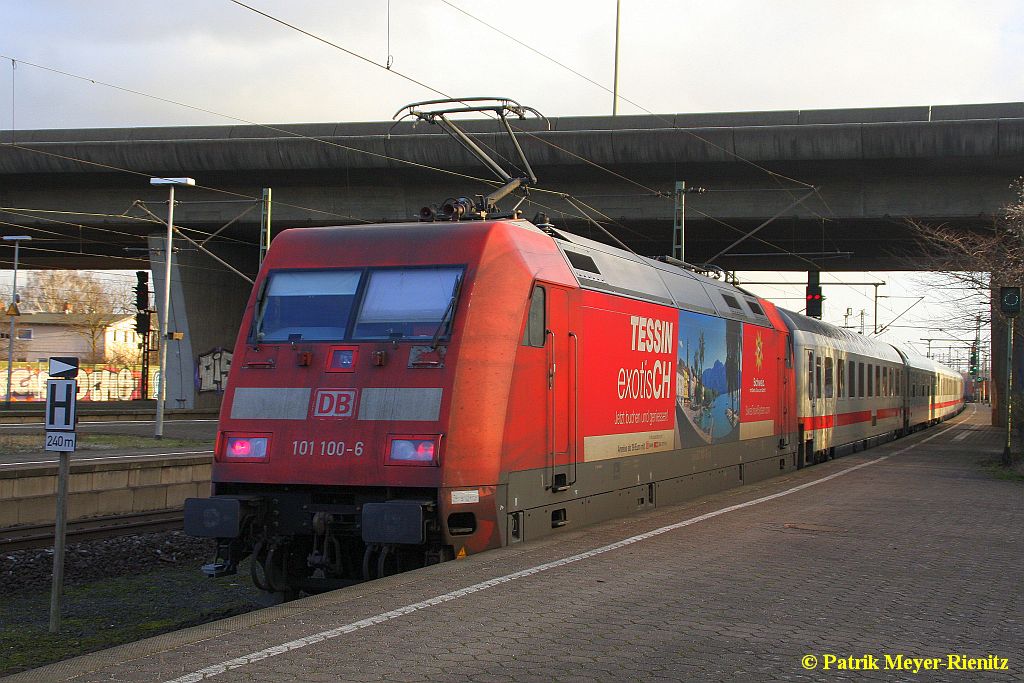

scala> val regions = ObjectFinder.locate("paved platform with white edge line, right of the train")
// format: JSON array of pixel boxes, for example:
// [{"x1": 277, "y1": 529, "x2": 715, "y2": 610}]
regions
[{"x1": 10, "y1": 407, "x2": 1024, "y2": 683}]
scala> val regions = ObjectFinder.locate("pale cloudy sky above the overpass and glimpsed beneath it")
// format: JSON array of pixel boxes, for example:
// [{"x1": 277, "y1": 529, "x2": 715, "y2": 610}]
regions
[{"x1": 0, "y1": 0, "x2": 1024, "y2": 362}]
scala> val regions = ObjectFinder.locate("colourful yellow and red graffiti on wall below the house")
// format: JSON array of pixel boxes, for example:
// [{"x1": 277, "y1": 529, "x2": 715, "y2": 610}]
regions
[{"x1": 0, "y1": 362, "x2": 160, "y2": 401}]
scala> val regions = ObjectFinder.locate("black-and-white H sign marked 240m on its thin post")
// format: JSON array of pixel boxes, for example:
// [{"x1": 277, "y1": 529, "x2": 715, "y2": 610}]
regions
[{"x1": 45, "y1": 357, "x2": 78, "y2": 633}]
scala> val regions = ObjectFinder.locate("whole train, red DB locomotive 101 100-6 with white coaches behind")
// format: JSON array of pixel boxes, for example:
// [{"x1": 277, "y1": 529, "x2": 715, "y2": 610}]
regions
[{"x1": 185, "y1": 98, "x2": 956, "y2": 594}]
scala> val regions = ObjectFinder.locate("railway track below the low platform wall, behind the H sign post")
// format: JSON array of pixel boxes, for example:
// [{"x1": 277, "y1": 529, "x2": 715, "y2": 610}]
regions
[{"x1": 0, "y1": 509, "x2": 182, "y2": 553}]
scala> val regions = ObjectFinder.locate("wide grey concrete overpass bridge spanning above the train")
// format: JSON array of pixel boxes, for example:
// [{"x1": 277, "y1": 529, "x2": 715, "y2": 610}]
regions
[{"x1": 0, "y1": 102, "x2": 1024, "y2": 405}]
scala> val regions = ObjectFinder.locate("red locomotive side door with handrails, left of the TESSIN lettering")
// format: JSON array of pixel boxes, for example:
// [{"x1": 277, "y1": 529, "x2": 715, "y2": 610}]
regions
[{"x1": 544, "y1": 283, "x2": 580, "y2": 492}]
